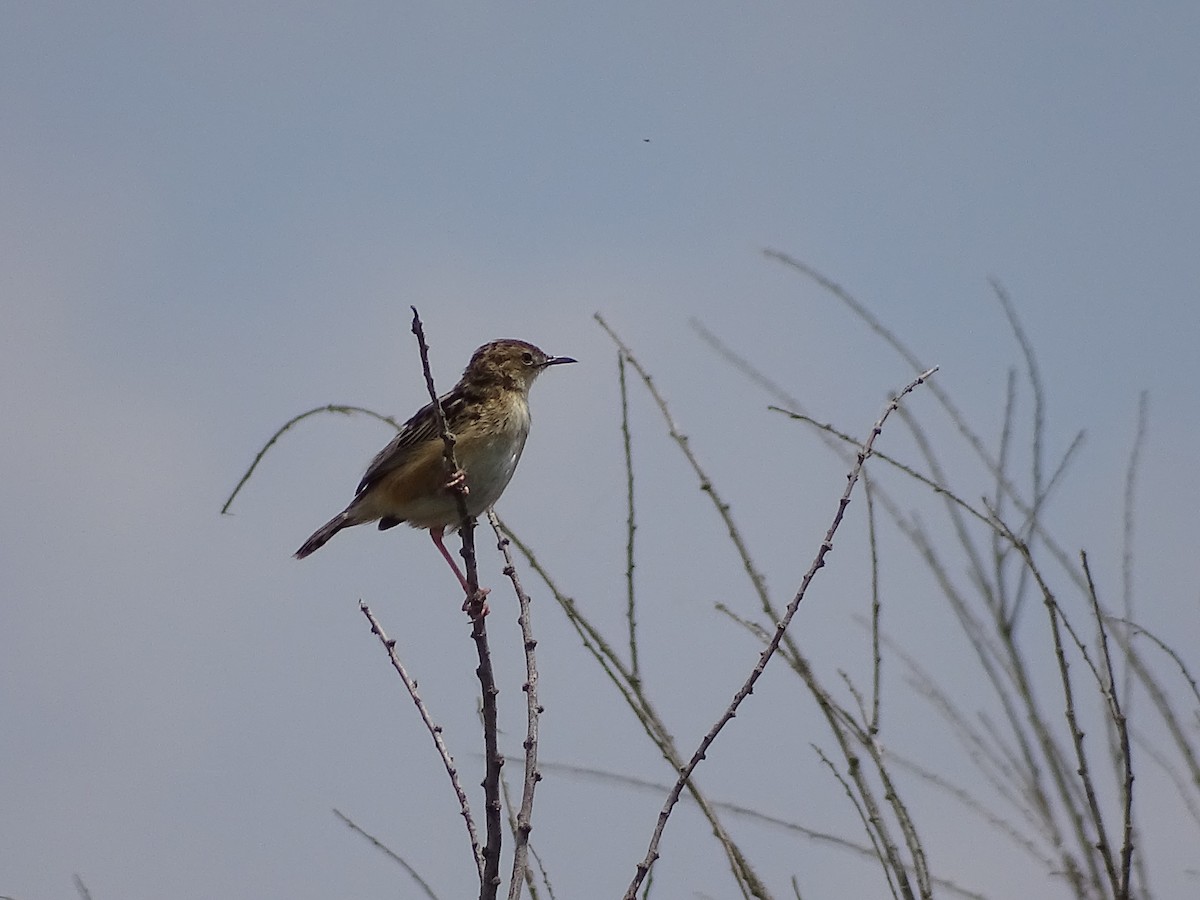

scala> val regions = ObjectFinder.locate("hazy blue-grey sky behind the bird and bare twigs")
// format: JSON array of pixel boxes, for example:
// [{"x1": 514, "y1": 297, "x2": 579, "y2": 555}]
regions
[{"x1": 0, "y1": 7, "x2": 1200, "y2": 900}]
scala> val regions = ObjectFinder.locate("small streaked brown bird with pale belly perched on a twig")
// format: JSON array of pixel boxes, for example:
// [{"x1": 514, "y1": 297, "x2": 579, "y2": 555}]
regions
[{"x1": 295, "y1": 340, "x2": 575, "y2": 590}]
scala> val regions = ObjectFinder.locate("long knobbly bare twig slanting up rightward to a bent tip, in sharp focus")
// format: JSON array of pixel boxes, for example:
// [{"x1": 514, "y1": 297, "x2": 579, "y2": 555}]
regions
[{"x1": 624, "y1": 367, "x2": 937, "y2": 900}]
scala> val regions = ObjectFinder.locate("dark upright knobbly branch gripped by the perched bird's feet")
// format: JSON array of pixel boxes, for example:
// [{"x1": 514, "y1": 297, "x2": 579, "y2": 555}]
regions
[{"x1": 409, "y1": 306, "x2": 504, "y2": 900}]
